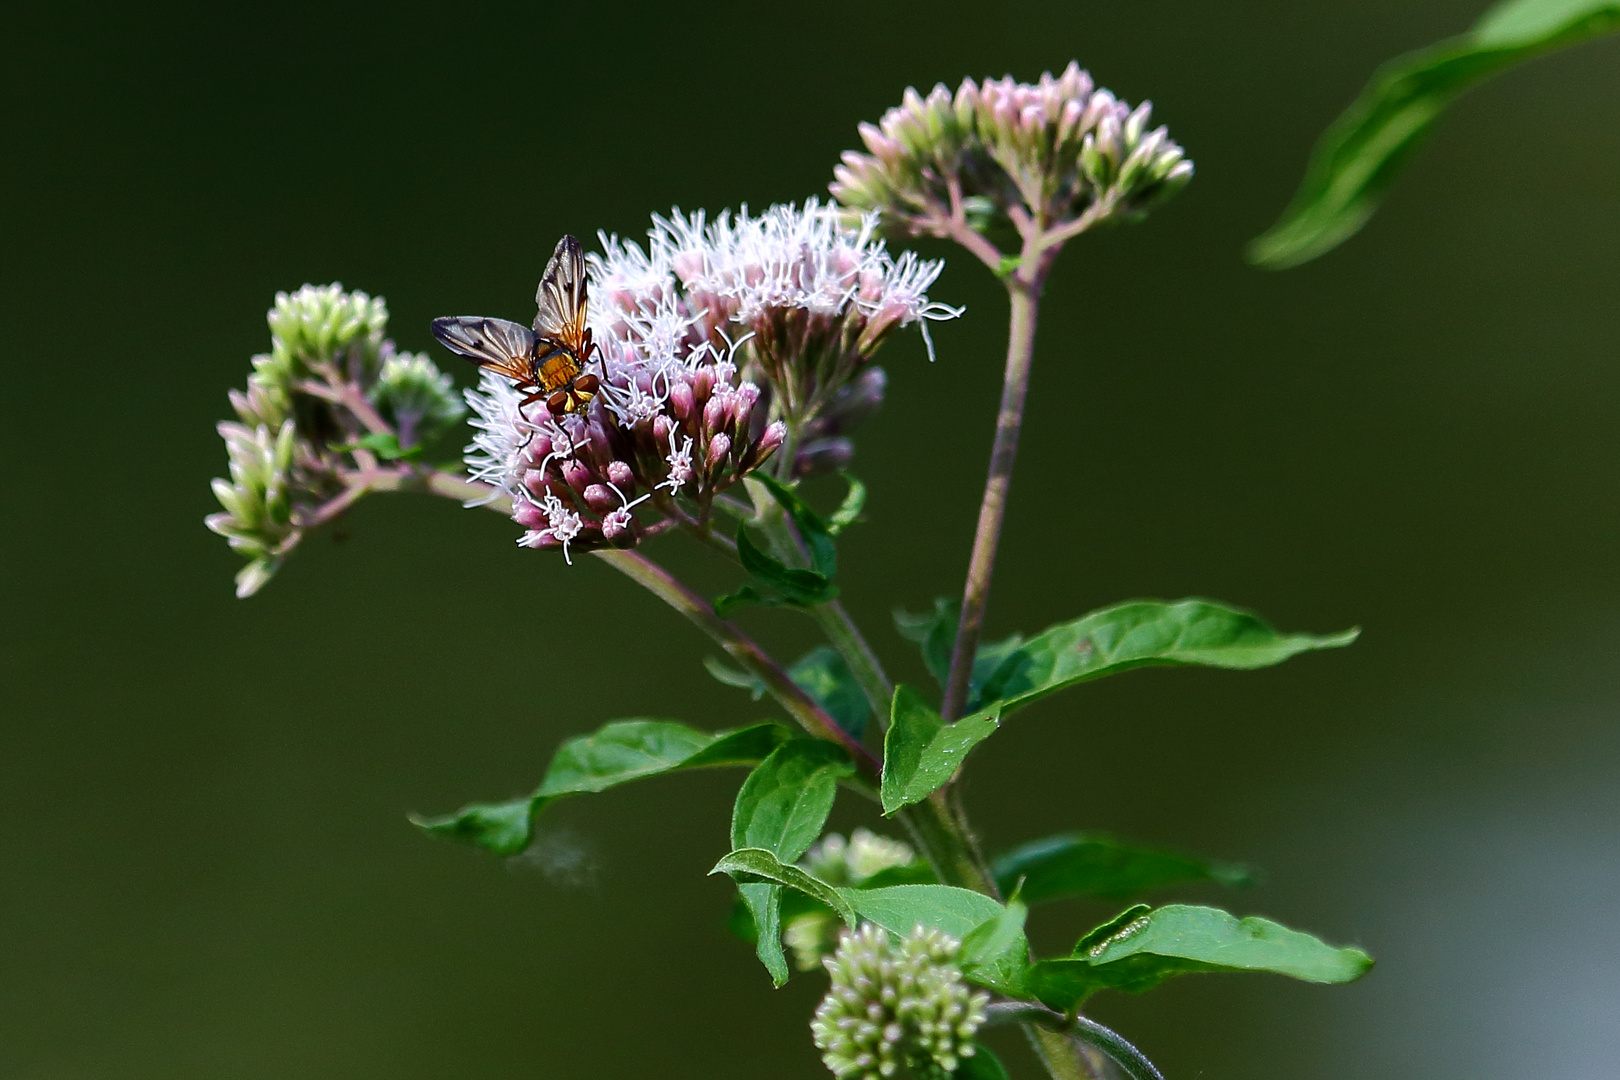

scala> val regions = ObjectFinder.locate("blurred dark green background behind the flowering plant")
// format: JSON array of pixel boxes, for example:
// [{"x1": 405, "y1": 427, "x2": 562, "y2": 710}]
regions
[{"x1": 0, "y1": 0, "x2": 1620, "y2": 1080}]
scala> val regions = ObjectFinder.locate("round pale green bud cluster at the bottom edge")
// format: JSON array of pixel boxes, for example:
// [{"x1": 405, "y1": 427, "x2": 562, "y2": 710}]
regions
[{"x1": 810, "y1": 923, "x2": 990, "y2": 1080}]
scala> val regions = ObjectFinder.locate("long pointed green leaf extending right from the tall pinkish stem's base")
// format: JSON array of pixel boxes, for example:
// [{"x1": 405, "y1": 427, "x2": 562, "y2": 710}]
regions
[{"x1": 982, "y1": 599, "x2": 1359, "y2": 716}]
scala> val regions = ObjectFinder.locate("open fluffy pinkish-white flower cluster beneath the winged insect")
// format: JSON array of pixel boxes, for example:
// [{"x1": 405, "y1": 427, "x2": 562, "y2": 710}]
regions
[{"x1": 467, "y1": 199, "x2": 956, "y2": 557}]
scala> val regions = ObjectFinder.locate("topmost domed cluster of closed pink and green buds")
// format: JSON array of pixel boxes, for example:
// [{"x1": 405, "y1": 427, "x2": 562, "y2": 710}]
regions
[{"x1": 831, "y1": 63, "x2": 1192, "y2": 244}]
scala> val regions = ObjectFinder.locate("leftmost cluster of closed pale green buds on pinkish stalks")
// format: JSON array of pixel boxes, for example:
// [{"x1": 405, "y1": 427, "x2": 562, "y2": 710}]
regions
[{"x1": 204, "y1": 285, "x2": 463, "y2": 596}]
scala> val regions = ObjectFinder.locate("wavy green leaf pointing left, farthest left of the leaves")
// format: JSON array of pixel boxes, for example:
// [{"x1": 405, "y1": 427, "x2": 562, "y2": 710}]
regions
[{"x1": 411, "y1": 719, "x2": 792, "y2": 855}]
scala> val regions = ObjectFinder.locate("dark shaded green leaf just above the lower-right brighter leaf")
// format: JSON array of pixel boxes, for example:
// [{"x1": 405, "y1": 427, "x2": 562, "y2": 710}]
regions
[{"x1": 991, "y1": 832, "x2": 1254, "y2": 904}]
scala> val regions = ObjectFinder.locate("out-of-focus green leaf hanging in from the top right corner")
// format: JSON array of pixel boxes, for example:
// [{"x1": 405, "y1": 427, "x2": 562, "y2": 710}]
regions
[{"x1": 1247, "y1": 0, "x2": 1620, "y2": 269}]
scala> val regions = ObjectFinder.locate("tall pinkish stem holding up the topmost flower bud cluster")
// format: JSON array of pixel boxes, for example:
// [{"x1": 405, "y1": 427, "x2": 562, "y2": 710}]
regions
[{"x1": 940, "y1": 275, "x2": 1045, "y2": 721}]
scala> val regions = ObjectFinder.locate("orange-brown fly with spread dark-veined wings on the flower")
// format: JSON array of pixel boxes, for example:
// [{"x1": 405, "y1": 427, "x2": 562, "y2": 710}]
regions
[{"x1": 433, "y1": 236, "x2": 601, "y2": 416}]
